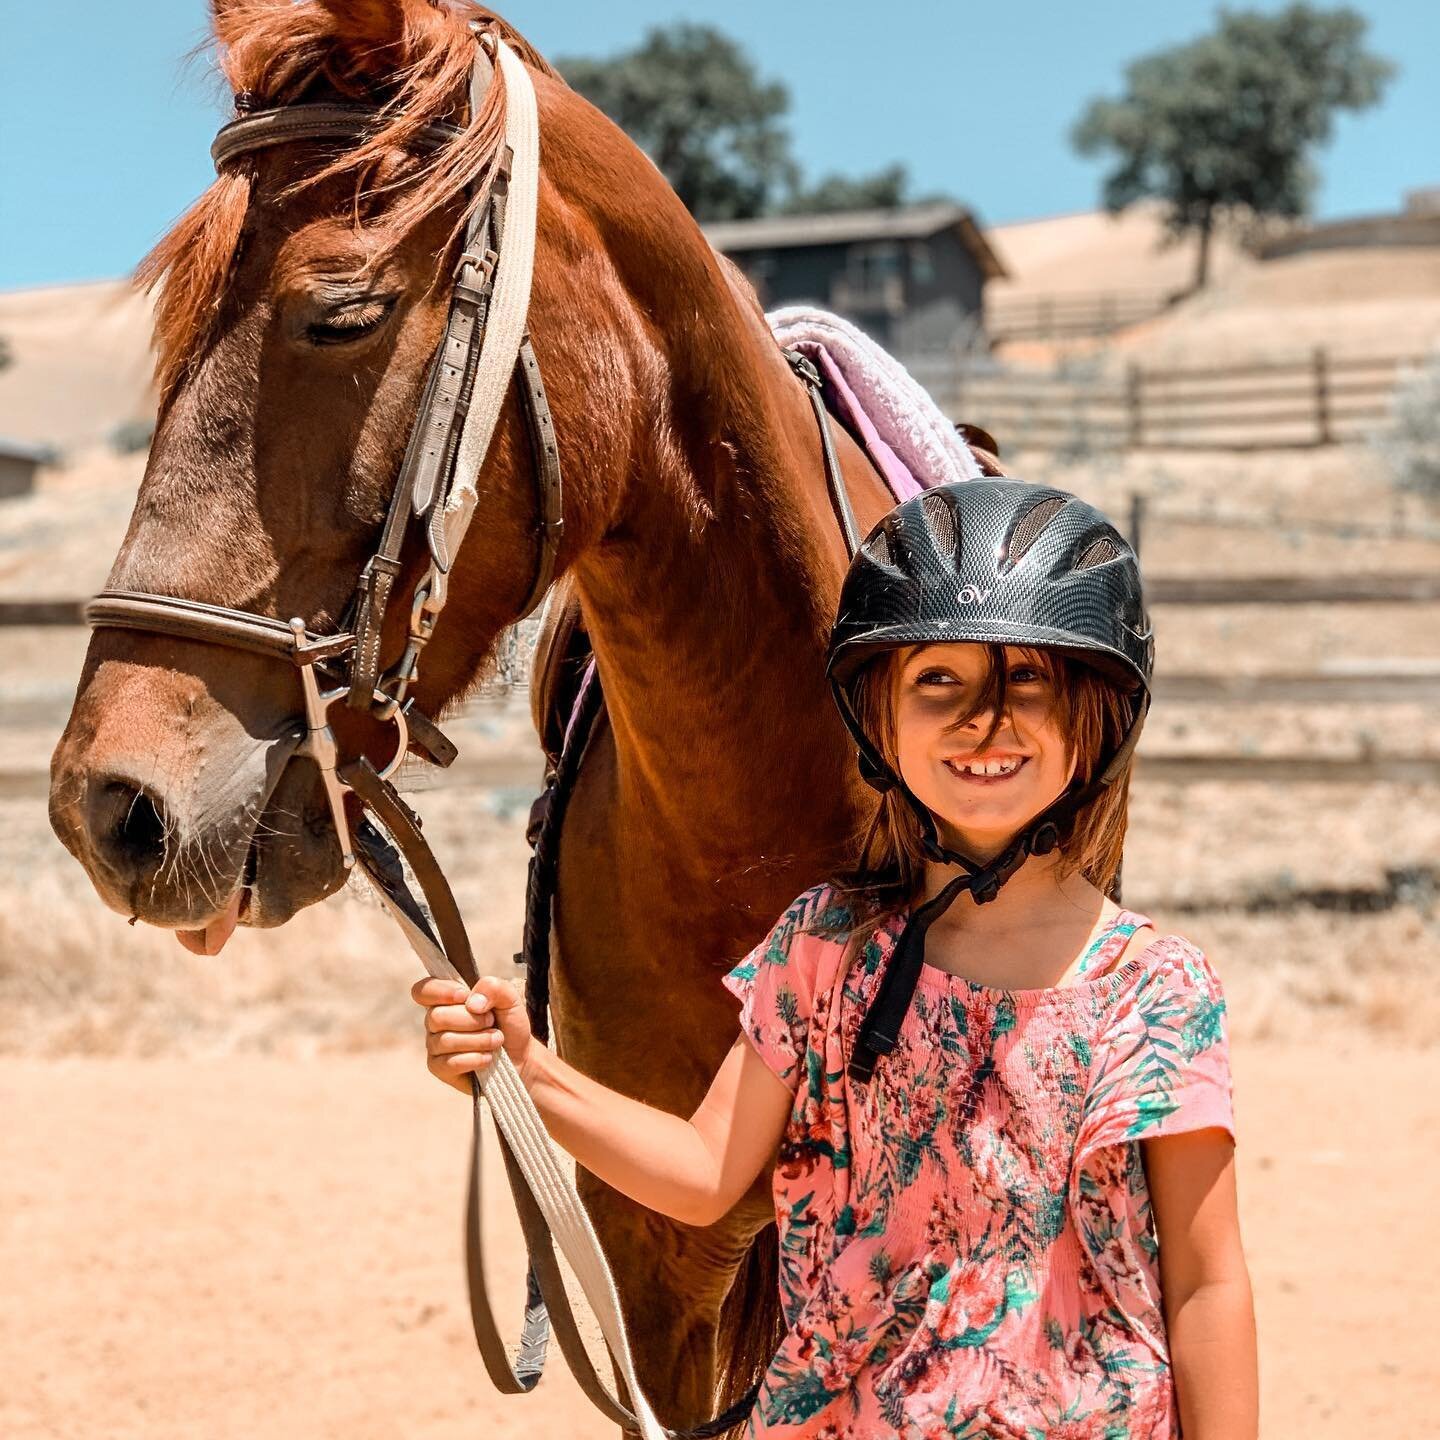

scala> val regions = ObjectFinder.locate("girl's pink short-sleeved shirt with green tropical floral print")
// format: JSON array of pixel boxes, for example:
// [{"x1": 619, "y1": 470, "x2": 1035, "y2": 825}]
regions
[{"x1": 724, "y1": 887, "x2": 1234, "y2": 1440}]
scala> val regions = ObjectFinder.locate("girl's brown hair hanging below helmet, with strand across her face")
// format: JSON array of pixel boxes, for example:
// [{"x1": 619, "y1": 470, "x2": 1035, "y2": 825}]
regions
[{"x1": 837, "y1": 645, "x2": 1135, "y2": 923}]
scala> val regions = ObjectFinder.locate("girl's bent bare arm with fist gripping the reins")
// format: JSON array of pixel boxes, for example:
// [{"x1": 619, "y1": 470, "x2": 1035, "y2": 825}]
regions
[{"x1": 412, "y1": 976, "x2": 793, "y2": 1225}]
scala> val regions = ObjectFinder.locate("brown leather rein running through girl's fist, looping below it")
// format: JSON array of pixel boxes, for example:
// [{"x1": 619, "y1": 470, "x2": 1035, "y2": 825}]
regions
[{"x1": 338, "y1": 759, "x2": 659, "y2": 1430}]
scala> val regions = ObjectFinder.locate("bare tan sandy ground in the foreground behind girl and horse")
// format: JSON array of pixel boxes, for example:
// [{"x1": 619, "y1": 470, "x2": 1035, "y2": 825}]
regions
[{"x1": 0, "y1": 1044, "x2": 1440, "y2": 1440}]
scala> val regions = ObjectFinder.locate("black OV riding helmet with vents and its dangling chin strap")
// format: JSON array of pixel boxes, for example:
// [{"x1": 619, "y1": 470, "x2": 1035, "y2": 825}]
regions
[{"x1": 827, "y1": 480, "x2": 1155, "y2": 1079}]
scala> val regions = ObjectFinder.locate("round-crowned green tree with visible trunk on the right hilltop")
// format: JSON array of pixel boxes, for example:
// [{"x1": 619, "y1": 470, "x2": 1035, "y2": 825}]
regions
[{"x1": 1071, "y1": 4, "x2": 1394, "y2": 289}]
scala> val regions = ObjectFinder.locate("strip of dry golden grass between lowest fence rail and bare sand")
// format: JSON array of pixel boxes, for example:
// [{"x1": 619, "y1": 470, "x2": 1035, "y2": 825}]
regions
[{"x1": 0, "y1": 782, "x2": 1440, "y2": 1057}]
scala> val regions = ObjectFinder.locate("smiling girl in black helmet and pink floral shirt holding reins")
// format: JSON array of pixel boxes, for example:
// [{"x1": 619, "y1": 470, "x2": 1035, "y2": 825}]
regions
[{"x1": 415, "y1": 480, "x2": 1257, "y2": 1440}]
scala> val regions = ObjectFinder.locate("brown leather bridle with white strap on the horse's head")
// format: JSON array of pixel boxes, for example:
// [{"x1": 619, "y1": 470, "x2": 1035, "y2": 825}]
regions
[{"x1": 85, "y1": 35, "x2": 564, "y2": 870}]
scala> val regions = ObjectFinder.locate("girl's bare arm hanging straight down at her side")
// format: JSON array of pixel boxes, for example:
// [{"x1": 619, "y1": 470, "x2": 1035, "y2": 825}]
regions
[{"x1": 1140, "y1": 1126, "x2": 1260, "y2": 1440}]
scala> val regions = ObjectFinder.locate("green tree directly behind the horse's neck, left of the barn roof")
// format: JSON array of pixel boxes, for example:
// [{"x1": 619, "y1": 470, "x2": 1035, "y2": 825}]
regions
[{"x1": 557, "y1": 24, "x2": 796, "y2": 220}]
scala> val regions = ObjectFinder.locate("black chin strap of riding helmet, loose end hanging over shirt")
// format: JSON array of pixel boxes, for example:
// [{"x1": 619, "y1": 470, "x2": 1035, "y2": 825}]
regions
[{"x1": 847, "y1": 697, "x2": 1149, "y2": 1084}]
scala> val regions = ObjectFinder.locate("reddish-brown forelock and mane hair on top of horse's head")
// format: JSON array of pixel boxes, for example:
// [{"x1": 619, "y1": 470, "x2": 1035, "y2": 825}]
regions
[{"x1": 134, "y1": 0, "x2": 556, "y2": 397}]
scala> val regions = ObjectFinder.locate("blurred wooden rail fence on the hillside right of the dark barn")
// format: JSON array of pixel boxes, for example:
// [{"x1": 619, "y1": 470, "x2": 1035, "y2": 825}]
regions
[{"x1": 907, "y1": 347, "x2": 1423, "y2": 452}]
